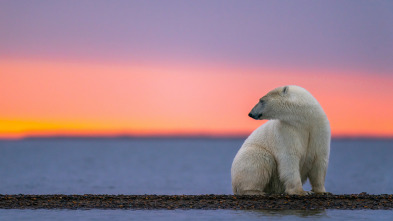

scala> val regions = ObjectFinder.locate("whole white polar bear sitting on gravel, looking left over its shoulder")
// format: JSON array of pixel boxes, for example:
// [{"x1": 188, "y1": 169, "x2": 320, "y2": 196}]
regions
[{"x1": 231, "y1": 85, "x2": 330, "y2": 195}]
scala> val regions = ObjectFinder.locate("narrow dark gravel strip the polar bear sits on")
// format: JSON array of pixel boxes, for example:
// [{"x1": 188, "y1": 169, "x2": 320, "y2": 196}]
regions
[{"x1": 0, "y1": 193, "x2": 393, "y2": 210}]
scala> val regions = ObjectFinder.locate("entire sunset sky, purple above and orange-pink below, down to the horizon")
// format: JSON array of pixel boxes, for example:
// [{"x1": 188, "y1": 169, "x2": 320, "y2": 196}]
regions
[{"x1": 0, "y1": 0, "x2": 393, "y2": 138}]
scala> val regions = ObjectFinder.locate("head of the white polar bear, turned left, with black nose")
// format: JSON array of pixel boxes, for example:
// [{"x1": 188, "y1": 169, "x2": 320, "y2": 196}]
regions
[{"x1": 248, "y1": 85, "x2": 318, "y2": 120}]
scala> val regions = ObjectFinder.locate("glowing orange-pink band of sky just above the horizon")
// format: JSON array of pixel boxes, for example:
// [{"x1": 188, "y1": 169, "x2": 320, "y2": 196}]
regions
[{"x1": 0, "y1": 59, "x2": 393, "y2": 138}]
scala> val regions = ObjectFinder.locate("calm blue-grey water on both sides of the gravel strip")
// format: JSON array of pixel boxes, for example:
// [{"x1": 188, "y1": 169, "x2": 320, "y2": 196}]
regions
[{"x1": 0, "y1": 138, "x2": 393, "y2": 220}]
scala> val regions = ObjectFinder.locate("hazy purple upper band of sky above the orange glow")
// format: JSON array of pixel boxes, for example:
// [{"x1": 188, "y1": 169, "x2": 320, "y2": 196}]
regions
[{"x1": 0, "y1": 0, "x2": 393, "y2": 74}]
